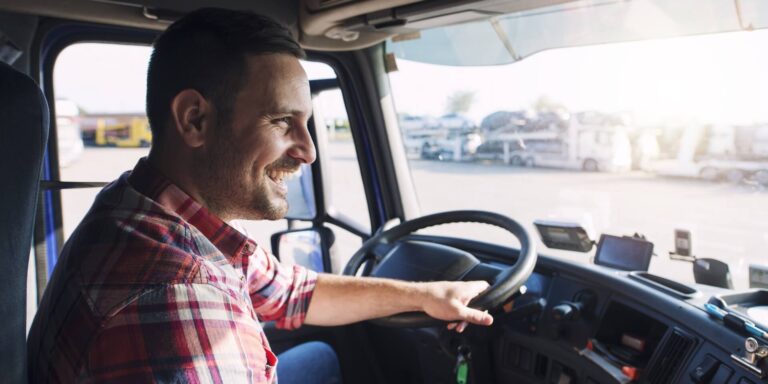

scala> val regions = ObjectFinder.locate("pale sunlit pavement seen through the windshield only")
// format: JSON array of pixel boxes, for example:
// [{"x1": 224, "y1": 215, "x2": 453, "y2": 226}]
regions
[{"x1": 412, "y1": 161, "x2": 768, "y2": 288}]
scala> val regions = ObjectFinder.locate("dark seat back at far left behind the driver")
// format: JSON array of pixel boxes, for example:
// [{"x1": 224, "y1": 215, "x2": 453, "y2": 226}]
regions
[{"x1": 0, "y1": 62, "x2": 48, "y2": 383}]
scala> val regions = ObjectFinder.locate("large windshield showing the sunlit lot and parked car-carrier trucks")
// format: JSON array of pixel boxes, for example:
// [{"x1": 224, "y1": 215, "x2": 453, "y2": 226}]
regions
[{"x1": 388, "y1": 6, "x2": 768, "y2": 289}]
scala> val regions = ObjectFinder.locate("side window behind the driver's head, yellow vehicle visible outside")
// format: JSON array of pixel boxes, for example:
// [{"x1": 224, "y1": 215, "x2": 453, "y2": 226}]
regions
[{"x1": 53, "y1": 43, "x2": 152, "y2": 239}]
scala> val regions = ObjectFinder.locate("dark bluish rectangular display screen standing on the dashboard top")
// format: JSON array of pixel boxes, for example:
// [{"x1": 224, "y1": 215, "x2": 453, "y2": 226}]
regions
[{"x1": 595, "y1": 235, "x2": 653, "y2": 271}]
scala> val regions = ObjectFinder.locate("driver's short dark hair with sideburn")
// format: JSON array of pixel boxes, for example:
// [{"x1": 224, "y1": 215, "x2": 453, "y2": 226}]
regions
[{"x1": 147, "y1": 8, "x2": 305, "y2": 142}]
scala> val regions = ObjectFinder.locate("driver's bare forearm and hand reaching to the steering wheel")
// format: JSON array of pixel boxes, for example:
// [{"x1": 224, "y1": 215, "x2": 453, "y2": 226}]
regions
[{"x1": 305, "y1": 274, "x2": 493, "y2": 326}]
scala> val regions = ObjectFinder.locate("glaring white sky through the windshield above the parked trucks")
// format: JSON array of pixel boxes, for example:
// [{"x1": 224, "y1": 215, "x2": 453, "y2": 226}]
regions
[{"x1": 390, "y1": 31, "x2": 768, "y2": 124}]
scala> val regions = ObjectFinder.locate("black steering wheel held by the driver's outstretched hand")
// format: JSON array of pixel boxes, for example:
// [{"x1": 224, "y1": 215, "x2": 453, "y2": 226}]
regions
[{"x1": 344, "y1": 211, "x2": 537, "y2": 327}]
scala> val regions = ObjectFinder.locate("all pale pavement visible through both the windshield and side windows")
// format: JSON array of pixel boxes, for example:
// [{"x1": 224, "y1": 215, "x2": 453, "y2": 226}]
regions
[{"x1": 62, "y1": 142, "x2": 768, "y2": 288}]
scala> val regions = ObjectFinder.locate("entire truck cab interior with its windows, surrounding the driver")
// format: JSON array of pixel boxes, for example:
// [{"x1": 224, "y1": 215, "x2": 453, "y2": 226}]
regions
[{"x1": 0, "y1": 0, "x2": 768, "y2": 384}]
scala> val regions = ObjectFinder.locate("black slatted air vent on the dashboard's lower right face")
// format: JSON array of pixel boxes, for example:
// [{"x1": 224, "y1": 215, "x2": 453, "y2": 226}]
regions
[{"x1": 646, "y1": 329, "x2": 696, "y2": 384}]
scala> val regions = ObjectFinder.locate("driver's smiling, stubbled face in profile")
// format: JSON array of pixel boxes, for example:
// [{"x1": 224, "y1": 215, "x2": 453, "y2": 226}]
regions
[{"x1": 195, "y1": 54, "x2": 315, "y2": 220}]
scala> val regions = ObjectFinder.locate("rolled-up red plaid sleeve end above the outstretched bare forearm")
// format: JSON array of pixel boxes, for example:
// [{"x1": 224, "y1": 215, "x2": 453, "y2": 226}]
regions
[{"x1": 248, "y1": 247, "x2": 317, "y2": 329}]
